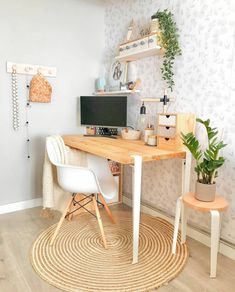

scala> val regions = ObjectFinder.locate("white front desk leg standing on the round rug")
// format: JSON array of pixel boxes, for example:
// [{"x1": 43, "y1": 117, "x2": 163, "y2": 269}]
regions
[{"x1": 132, "y1": 155, "x2": 142, "y2": 264}]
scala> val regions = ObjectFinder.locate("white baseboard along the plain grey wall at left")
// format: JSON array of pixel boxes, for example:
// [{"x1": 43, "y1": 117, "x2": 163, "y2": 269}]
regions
[{"x1": 0, "y1": 198, "x2": 42, "y2": 214}]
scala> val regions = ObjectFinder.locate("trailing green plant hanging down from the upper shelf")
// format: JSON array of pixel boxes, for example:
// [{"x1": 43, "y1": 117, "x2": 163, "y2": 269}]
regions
[{"x1": 152, "y1": 9, "x2": 181, "y2": 91}]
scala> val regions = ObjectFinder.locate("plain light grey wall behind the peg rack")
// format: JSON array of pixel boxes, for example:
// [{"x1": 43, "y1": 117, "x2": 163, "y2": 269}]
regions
[{"x1": 0, "y1": 0, "x2": 104, "y2": 205}]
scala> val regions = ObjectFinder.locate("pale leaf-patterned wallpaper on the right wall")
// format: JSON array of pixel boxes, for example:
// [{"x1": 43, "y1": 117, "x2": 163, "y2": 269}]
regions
[{"x1": 105, "y1": 0, "x2": 235, "y2": 243}]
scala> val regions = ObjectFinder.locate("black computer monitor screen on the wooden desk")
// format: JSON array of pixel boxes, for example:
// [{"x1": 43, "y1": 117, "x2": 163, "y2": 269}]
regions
[{"x1": 80, "y1": 96, "x2": 127, "y2": 127}]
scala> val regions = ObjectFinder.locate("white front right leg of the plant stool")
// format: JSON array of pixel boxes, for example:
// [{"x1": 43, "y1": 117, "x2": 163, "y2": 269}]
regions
[{"x1": 210, "y1": 210, "x2": 220, "y2": 278}]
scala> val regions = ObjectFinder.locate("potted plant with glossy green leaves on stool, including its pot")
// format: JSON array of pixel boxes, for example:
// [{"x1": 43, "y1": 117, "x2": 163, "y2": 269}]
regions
[{"x1": 181, "y1": 119, "x2": 226, "y2": 202}]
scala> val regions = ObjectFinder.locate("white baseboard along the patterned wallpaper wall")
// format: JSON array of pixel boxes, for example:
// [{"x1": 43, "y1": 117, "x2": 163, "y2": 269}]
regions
[{"x1": 123, "y1": 196, "x2": 235, "y2": 260}]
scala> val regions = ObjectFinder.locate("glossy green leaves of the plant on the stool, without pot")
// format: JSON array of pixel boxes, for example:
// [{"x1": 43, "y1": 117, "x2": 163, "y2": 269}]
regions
[{"x1": 181, "y1": 119, "x2": 226, "y2": 184}]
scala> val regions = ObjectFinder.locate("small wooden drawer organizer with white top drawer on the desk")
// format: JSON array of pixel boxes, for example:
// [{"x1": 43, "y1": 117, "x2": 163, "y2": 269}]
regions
[{"x1": 157, "y1": 113, "x2": 196, "y2": 150}]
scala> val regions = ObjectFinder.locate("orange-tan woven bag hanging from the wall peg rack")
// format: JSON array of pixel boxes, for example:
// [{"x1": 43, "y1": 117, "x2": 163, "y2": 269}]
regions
[{"x1": 29, "y1": 73, "x2": 52, "y2": 102}]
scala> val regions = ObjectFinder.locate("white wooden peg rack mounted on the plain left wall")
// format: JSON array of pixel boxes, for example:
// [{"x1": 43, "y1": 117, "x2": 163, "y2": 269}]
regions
[{"x1": 7, "y1": 62, "x2": 57, "y2": 77}]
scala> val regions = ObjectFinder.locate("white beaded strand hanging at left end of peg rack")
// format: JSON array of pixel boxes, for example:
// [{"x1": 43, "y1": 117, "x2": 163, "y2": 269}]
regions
[{"x1": 11, "y1": 68, "x2": 20, "y2": 131}]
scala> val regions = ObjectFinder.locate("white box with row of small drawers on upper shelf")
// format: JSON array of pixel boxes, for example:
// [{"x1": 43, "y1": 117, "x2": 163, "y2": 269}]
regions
[{"x1": 119, "y1": 33, "x2": 159, "y2": 56}]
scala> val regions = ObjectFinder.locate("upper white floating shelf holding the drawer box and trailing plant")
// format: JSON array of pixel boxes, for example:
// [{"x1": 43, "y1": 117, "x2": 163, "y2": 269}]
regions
[{"x1": 115, "y1": 46, "x2": 163, "y2": 62}]
